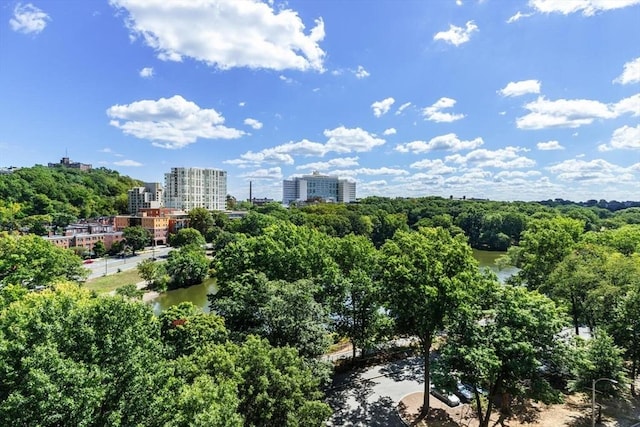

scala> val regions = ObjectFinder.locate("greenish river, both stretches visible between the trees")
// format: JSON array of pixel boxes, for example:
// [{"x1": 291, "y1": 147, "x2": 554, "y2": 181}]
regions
[{"x1": 149, "y1": 249, "x2": 517, "y2": 314}]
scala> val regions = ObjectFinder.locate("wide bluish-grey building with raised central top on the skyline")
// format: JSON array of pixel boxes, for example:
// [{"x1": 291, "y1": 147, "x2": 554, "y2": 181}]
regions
[{"x1": 282, "y1": 171, "x2": 356, "y2": 205}]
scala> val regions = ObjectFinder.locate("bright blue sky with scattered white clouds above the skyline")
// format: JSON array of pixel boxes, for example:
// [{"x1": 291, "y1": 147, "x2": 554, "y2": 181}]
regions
[{"x1": 0, "y1": 0, "x2": 640, "y2": 200}]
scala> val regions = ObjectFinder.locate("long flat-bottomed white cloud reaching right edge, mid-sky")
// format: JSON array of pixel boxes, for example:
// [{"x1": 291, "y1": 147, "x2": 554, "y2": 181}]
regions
[{"x1": 516, "y1": 94, "x2": 640, "y2": 129}]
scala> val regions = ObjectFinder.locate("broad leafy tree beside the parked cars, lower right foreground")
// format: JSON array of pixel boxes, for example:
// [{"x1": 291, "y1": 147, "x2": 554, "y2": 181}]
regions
[{"x1": 436, "y1": 280, "x2": 564, "y2": 427}]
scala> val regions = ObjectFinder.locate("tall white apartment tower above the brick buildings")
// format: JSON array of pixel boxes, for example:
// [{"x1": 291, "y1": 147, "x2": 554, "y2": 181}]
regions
[{"x1": 164, "y1": 168, "x2": 227, "y2": 212}]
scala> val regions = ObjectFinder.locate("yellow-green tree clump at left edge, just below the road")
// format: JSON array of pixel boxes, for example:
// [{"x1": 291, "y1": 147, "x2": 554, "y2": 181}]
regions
[{"x1": 0, "y1": 233, "x2": 88, "y2": 288}]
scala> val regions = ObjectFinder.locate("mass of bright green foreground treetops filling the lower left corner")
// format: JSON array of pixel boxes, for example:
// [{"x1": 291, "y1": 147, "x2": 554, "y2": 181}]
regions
[{"x1": 0, "y1": 284, "x2": 330, "y2": 427}]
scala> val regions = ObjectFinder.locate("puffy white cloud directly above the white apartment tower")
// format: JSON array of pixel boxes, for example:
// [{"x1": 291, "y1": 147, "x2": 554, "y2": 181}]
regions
[{"x1": 107, "y1": 95, "x2": 244, "y2": 148}]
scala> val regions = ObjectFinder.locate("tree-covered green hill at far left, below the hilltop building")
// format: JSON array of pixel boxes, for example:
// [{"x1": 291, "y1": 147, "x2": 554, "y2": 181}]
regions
[{"x1": 0, "y1": 165, "x2": 142, "y2": 230}]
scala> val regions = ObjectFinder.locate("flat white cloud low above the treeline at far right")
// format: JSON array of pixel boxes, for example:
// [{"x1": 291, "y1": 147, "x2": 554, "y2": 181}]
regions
[{"x1": 547, "y1": 159, "x2": 635, "y2": 184}]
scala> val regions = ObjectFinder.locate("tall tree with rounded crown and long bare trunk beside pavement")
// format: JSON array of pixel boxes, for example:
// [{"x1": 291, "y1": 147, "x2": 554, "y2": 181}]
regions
[{"x1": 381, "y1": 228, "x2": 479, "y2": 415}]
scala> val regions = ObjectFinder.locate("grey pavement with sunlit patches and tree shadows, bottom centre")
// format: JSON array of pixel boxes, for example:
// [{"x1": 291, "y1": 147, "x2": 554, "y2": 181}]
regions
[{"x1": 327, "y1": 357, "x2": 424, "y2": 427}]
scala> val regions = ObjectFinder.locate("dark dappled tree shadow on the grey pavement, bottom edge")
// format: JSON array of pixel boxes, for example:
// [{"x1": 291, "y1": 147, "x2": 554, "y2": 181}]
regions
[{"x1": 326, "y1": 380, "x2": 403, "y2": 427}]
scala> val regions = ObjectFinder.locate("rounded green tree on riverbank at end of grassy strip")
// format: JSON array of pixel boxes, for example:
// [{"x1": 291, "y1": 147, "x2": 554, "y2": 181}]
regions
[{"x1": 166, "y1": 245, "x2": 209, "y2": 288}]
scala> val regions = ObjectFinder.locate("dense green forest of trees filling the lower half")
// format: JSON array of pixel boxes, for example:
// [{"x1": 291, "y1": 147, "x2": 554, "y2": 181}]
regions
[{"x1": 0, "y1": 167, "x2": 640, "y2": 426}]
